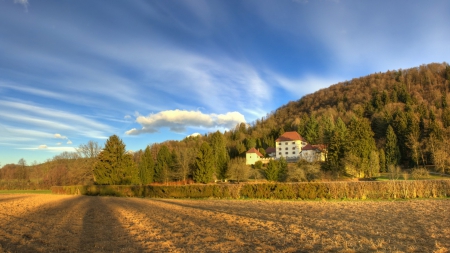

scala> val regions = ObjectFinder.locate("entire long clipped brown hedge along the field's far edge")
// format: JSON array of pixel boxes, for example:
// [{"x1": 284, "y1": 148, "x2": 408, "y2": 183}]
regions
[{"x1": 52, "y1": 180, "x2": 450, "y2": 200}]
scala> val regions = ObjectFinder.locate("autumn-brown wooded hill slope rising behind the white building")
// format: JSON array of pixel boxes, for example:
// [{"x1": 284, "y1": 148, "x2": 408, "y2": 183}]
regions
[{"x1": 252, "y1": 63, "x2": 450, "y2": 169}]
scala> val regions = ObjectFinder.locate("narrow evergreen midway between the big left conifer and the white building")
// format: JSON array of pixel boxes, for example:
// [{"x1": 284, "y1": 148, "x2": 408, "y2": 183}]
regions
[{"x1": 192, "y1": 142, "x2": 214, "y2": 184}]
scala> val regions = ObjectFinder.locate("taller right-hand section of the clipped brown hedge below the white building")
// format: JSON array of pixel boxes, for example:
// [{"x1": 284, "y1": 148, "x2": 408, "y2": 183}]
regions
[{"x1": 240, "y1": 180, "x2": 450, "y2": 200}]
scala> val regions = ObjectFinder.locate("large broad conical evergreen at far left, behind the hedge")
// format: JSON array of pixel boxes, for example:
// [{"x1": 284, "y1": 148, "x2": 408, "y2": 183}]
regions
[{"x1": 94, "y1": 135, "x2": 137, "y2": 185}]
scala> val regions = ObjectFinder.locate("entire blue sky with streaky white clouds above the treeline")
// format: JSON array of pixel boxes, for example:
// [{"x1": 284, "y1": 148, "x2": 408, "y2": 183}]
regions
[{"x1": 0, "y1": 0, "x2": 450, "y2": 166}]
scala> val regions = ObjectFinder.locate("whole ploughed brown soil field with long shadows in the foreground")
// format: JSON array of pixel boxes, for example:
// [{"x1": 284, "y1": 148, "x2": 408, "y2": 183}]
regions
[{"x1": 0, "y1": 194, "x2": 450, "y2": 252}]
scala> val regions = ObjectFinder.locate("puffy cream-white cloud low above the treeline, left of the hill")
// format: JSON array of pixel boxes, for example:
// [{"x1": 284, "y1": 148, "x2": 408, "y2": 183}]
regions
[{"x1": 125, "y1": 110, "x2": 245, "y2": 135}]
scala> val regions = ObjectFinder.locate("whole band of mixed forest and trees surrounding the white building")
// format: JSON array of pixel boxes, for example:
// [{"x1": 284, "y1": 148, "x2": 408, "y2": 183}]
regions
[{"x1": 0, "y1": 63, "x2": 450, "y2": 188}]
